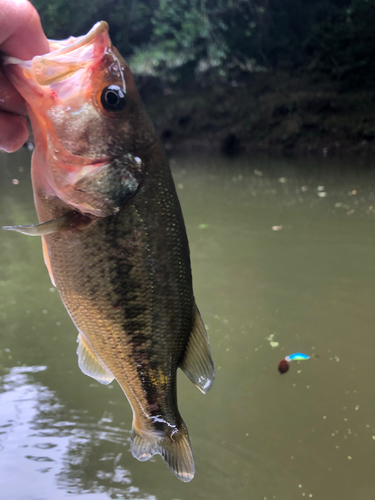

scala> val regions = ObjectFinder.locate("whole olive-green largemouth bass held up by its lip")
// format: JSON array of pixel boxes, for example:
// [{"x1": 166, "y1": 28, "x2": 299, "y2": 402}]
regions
[{"x1": 3, "y1": 21, "x2": 215, "y2": 482}]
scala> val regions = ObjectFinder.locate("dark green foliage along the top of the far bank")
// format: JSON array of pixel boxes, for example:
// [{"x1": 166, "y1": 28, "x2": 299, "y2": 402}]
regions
[{"x1": 33, "y1": 0, "x2": 375, "y2": 85}]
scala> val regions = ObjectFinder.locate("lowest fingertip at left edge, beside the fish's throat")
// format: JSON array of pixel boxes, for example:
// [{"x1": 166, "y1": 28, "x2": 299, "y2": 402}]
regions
[{"x1": 0, "y1": 111, "x2": 29, "y2": 153}]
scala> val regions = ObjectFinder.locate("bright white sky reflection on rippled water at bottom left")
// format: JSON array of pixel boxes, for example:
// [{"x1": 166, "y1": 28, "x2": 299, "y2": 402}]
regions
[{"x1": 0, "y1": 366, "x2": 155, "y2": 500}]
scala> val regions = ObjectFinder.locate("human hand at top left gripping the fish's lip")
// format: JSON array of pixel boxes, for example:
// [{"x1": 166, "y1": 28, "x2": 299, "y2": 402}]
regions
[{"x1": 0, "y1": 0, "x2": 49, "y2": 153}]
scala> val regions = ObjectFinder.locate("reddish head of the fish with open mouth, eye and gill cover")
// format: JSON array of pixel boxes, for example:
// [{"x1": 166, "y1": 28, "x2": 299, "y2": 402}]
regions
[{"x1": 3, "y1": 21, "x2": 140, "y2": 217}]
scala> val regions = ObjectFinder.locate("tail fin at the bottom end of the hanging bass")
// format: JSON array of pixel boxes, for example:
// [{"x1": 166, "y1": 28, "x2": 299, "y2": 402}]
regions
[{"x1": 131, "y1": 422, "x2": 195, "y2": 483}]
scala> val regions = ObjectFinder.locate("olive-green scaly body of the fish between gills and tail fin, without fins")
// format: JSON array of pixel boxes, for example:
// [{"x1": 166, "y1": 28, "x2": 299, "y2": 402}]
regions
[{"x1": 38, "y1": 152, "x2": 194, "y2": 432}]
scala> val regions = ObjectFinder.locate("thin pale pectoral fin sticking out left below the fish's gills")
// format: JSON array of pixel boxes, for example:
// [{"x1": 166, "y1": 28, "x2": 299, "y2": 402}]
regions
[{"x1": 3, "y1": 212, "x2": 95, "y2": 236}]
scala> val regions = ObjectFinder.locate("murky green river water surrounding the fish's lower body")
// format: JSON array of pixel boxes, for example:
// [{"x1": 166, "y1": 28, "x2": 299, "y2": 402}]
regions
[{"x1": 0, "y1": 151, "x2": 375, "y2": 500}]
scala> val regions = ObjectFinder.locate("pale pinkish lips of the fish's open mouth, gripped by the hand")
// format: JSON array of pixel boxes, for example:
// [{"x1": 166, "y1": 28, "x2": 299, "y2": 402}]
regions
[{"x1": 2, "y1": 21, "x2": 110, "y2": 87}]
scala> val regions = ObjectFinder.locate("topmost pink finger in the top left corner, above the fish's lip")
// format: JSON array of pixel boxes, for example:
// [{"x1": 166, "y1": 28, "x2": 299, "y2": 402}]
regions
[{"x1": 0, "y1": 0, "x2": 49, "y2": 61}]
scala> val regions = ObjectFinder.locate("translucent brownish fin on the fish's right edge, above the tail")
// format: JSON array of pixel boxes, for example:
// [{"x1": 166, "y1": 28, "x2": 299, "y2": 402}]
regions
[{"x1": 180, "y1": 304, "x2": 215, "y2": 394}]
